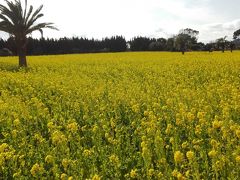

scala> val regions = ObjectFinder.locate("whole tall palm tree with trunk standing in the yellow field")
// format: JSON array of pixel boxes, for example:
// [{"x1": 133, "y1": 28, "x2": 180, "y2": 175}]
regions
[{"x1": 0, "y1": 0, "x2": 58, "y2": 67}]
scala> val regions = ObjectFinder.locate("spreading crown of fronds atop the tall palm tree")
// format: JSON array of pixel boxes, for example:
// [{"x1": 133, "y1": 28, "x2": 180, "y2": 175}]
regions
[{"x1": 0, "y1": 0, "x2": 58, "y2": 36}]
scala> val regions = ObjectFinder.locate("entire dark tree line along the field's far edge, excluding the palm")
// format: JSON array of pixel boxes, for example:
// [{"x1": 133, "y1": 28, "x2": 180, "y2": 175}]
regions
[{"x1": 0, "y1": 28, "x2": 240, "y2": 56}]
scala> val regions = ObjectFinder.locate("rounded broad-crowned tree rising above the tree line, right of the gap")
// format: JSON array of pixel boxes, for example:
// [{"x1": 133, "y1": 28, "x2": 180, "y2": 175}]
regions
[{"x1": 175, "y1": 28, "x2": 199, "y2": 54}]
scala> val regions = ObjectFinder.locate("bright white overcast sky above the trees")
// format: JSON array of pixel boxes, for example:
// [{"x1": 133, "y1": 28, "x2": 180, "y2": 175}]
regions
[{"x1": 0, "y1": 0, "x2": 240, "y2": 42}]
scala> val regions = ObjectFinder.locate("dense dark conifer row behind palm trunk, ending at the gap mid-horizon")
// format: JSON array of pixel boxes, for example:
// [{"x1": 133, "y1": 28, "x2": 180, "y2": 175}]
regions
[{"x1": 0, "y1": 36, "x2": 127, "y2": 55}]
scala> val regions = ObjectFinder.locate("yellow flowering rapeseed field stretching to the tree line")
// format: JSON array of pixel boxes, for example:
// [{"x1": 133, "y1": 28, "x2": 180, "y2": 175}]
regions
[{"x1": 0, "y1": 52, "x2": 240, "y2": 180}]
